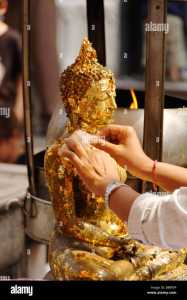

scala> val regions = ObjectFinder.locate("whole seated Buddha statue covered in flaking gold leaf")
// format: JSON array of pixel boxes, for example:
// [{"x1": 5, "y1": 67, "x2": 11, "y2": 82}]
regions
[{"x1": 45, "y1": 39, "x2": 186, "y2": 280}]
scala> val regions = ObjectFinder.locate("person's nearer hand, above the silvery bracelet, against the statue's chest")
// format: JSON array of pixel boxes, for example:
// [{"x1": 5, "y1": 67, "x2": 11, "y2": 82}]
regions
[{"x1": 59, "y1": 131, "x2": 120, "y2": 196}]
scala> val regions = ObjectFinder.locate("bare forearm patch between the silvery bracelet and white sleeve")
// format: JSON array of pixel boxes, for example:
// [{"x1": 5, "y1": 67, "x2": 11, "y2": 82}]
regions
[{"x1": 109, "y1": 186, "x2": 140, "y2": 221}]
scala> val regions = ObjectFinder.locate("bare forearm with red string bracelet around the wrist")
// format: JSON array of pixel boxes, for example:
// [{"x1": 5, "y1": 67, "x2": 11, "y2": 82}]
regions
[{"x1": 140, "y1": 160, "x2": 187, "y2": 192}]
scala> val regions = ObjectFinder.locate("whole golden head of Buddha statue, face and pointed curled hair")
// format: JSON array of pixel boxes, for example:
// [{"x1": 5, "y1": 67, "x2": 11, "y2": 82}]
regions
[{"x1": 60, "y1": 38, "x2": 116, "y2": 127}]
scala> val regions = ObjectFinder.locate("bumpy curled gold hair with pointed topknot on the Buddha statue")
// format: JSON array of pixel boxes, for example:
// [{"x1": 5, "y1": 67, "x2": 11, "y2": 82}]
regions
[{"x1": 60, "y1": 38, "x2": 115, "y2": 118}]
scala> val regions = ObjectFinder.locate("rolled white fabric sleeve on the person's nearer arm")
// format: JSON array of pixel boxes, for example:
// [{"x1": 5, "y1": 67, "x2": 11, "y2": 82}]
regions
[{"x1": 128, "y1": 187, "x2": 187, "y2": 248}]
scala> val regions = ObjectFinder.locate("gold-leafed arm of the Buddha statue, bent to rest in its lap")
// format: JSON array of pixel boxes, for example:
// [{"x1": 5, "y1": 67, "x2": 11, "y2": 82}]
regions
[{"x1": 45, "y1": 143, "x2": 129, "y2": 247}]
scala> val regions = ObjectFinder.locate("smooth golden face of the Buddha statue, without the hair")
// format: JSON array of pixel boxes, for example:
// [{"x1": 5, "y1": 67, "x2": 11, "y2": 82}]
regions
[{"x1": 79, "y1": 79, "x2": 116, "y2": 125}]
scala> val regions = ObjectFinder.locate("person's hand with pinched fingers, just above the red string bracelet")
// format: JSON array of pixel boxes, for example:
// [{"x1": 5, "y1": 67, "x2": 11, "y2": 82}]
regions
[{"x1": 91, "y1": 125, "x2": 153, "y2": 179}]
